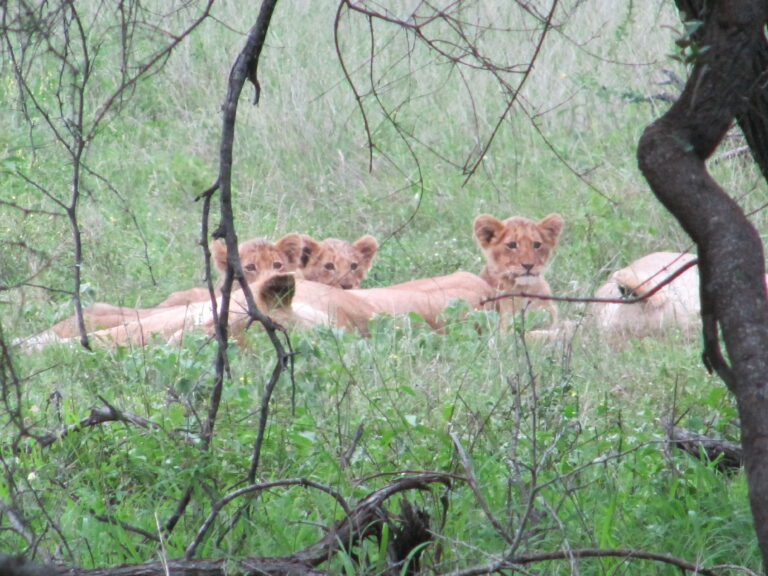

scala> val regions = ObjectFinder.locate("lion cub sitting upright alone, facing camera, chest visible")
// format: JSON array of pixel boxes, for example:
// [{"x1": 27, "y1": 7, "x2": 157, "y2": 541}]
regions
[{"x1": 474, "y1": 214, "x2": 563, "y2": 325}]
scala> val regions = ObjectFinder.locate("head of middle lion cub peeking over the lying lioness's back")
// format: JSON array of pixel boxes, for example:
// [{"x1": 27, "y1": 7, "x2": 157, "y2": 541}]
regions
[{"x1": 301, "y1": 235, "x2": 379, "y2": 290}]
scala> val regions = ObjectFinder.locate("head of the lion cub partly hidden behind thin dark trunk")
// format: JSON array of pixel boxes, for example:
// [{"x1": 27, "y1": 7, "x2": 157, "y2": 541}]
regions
[{"x1": 211, "y1": 234, "x2": 302, "y2": 284}]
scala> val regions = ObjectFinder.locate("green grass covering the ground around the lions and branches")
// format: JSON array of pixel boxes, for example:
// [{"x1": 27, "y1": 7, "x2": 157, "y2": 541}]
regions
[{"x1": 0, "y1": 0, "x2": 766, "y2": 574}]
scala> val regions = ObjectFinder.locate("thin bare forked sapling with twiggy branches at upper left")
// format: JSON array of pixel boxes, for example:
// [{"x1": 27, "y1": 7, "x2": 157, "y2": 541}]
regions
[{"x1": 0, "y1": 0, "x2": 214, "y2": 348}]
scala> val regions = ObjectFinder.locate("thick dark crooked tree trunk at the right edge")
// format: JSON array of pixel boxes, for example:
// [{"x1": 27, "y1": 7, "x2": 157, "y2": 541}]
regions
[{"x1": 637, "y1": 0, "x2": 768, "y2": 569}]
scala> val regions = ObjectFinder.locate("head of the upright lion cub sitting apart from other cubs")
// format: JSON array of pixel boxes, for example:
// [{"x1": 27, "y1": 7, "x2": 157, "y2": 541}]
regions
[{"x1": 474, "y1": 214, "x2": 563, "y2": 289}]
